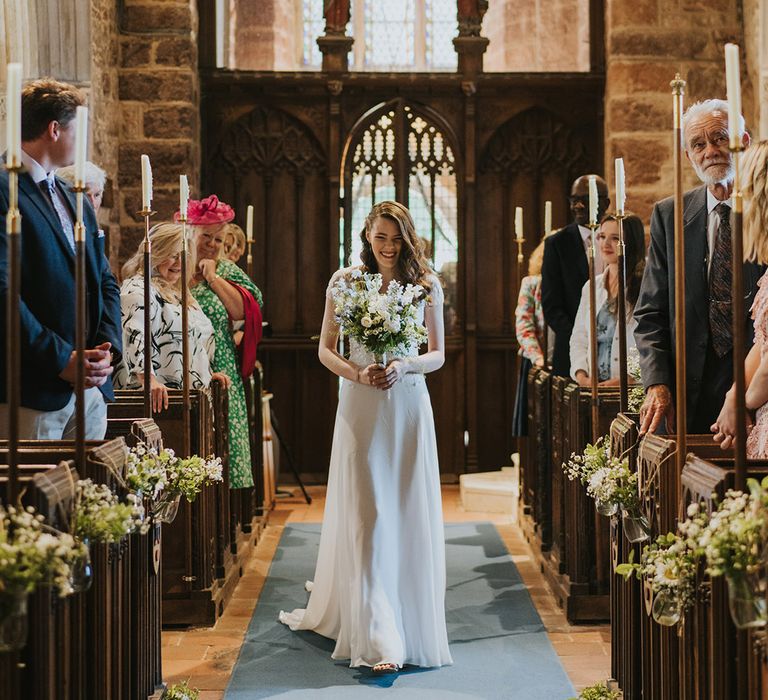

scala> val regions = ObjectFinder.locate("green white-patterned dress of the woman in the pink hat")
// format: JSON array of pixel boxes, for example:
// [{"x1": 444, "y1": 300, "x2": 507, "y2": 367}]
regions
[{"x1": 192, "y1": 260, "x2": 262, "y2": 489}]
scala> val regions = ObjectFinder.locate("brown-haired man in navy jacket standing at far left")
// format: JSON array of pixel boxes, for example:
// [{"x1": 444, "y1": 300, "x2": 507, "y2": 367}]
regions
[{"x1": 0, "y1": 80, "x2": 121, "y2": 440}]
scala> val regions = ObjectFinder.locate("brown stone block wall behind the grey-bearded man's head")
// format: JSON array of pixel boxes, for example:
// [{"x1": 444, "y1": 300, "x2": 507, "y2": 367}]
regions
[{"x1": 605, "y1": 0, "x2": 748, "y2": 223}]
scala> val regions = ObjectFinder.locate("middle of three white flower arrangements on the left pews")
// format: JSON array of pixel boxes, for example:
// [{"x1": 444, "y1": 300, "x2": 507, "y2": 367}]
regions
[{"x1": 70, "y1": 479, "x2": 149, "y2": 543}]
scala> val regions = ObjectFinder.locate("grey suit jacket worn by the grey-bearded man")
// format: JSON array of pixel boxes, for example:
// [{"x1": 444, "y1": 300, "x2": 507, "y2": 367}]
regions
[{"x1": 635, "y1": 186, "x2": 764, "y2": 418}]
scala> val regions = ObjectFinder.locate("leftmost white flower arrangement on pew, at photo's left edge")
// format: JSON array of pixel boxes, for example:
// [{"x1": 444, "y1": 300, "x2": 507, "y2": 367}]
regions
[{"x1": 0, "y1": 506, "x2": 88, "y2": 600}]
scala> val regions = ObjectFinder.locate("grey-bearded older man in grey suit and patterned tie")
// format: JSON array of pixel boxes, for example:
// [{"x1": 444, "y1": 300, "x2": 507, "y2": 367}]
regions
[{"x1": 635, "y1": 100, "x2": 752, "y2": 433}]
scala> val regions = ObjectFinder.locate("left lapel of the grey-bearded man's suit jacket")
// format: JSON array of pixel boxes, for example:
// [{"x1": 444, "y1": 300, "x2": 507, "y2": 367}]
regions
[{"x1": 683, "y1": 187, "x2": 709, "y2": 323}]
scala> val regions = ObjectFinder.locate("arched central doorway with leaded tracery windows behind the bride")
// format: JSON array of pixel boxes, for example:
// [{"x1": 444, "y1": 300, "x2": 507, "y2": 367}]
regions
[{"x1": 339, "y1": 99, "x2": 465, "y2": 473}]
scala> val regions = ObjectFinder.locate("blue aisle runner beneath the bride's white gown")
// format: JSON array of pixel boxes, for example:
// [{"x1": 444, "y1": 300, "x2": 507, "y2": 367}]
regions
[{"x1": 225, "y1": 523, "x2": 574, "y2": 700}]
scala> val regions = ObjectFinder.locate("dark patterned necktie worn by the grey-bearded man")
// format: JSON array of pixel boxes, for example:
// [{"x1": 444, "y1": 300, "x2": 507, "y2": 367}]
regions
[{"x1": 709, "y1": 202, "x2": 733, "y2": 357}]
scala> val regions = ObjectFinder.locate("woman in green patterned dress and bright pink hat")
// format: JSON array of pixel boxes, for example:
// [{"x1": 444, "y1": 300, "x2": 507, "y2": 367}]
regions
[{"x1": 187, "y1": 195, "x2": 262, "y2": 489}]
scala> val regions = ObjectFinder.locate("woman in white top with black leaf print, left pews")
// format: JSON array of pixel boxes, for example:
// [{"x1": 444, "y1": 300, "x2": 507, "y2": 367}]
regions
[{"x1": 114, "y1": 224, "x2": 229, "y2": 413}]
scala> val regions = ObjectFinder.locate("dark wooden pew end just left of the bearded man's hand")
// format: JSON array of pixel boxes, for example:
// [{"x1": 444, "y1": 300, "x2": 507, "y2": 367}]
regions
[{"x1": 611, "y1": 413, "x2": 642, "y2": 700}]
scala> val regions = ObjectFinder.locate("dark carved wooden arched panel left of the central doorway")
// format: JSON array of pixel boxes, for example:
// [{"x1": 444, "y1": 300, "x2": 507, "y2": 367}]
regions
[{"x1": 206, "y1": 106, "x2": 336, "y2": 474}]
